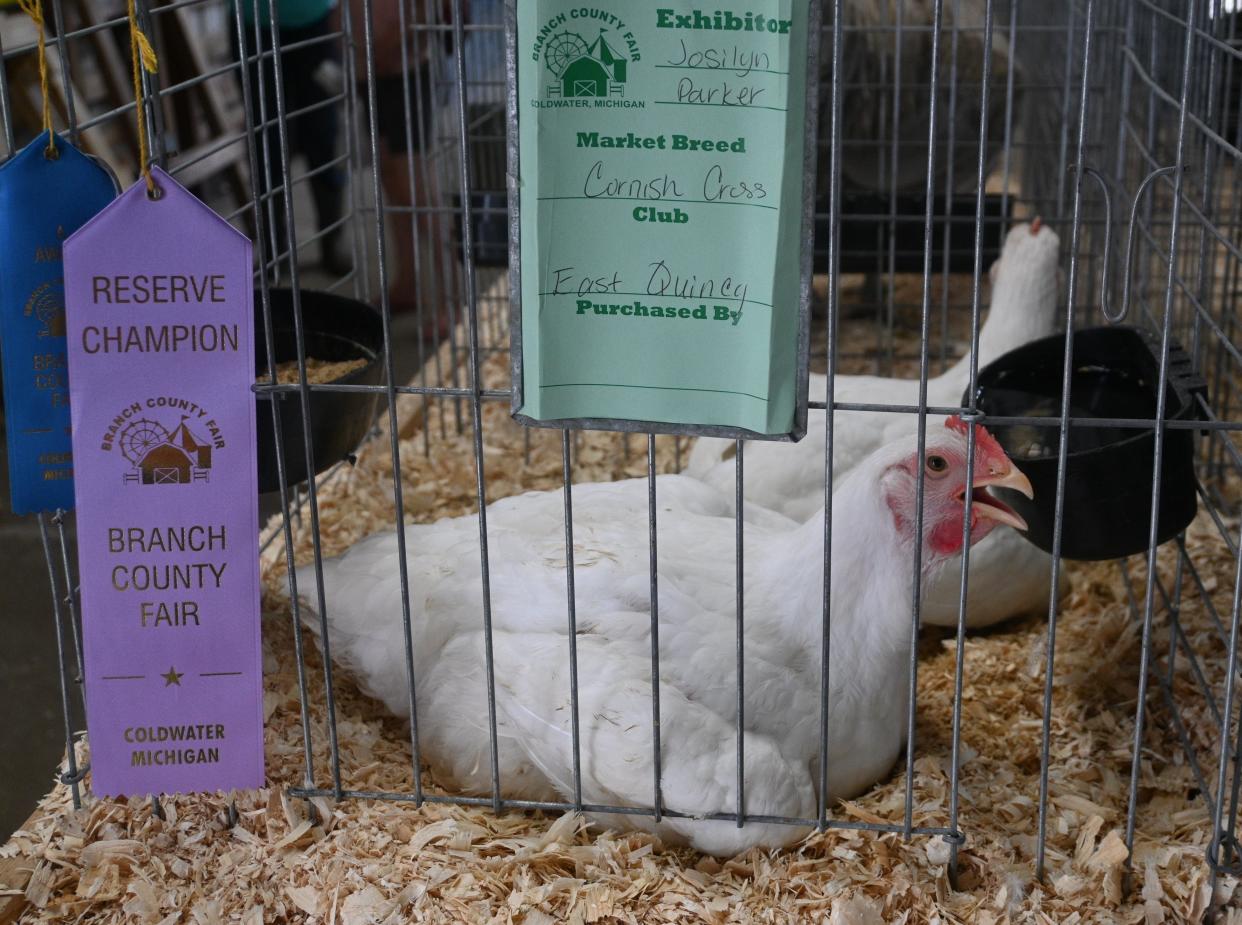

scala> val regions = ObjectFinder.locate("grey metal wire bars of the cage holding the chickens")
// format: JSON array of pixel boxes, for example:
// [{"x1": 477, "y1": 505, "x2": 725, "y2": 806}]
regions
[{"x1": 7, "y1": 0, "x2": 1242, "y2": 908}]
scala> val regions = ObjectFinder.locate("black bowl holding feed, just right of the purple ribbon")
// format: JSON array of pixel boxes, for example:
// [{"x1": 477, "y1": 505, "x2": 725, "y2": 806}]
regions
[{"x1": 255, "y1": 289, "x2": 384, "y2": 494}]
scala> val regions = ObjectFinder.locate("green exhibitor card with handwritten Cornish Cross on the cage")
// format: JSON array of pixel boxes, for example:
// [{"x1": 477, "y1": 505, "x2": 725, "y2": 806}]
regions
[{"x1": 509, "y1": 0, "x2": 818, "y2": 440}]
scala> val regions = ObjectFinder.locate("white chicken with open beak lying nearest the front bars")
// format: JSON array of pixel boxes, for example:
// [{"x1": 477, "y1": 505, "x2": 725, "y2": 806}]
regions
[{"x1": 298, "y1": 420, "x2": 1031, "y2": 855}]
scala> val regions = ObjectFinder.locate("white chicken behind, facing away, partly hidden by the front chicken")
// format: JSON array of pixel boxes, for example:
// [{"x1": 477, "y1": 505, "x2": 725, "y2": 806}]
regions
[{"x1": 686, "y1": 219, "x2": 1064, "y2": 627}]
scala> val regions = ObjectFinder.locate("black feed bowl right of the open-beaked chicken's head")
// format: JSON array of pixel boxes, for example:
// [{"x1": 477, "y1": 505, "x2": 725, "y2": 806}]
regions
[{"x1": 963, "y1": 327, "x2": 1205, "y2": 560}]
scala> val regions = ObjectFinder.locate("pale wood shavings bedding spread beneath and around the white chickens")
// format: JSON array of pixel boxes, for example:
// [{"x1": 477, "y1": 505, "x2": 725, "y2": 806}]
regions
[{"x1": 0, "y1": 278, "x2": 1242, "y2": 925}]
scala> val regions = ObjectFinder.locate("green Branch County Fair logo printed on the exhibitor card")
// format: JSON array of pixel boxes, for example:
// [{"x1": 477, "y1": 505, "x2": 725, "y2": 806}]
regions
[{"x1": 535, "y1": 16, "x2": 638, "y2": 99}]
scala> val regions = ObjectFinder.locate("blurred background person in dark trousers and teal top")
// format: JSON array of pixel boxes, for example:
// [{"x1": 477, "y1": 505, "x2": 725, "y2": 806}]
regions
[{"x1": 230, "y1": 0, "x2": 353, "y2": 276}]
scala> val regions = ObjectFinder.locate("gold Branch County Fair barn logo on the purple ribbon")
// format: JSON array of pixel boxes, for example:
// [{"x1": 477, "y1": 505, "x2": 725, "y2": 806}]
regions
[{"x1": 102, "y1": 397, "x2": 225, "y2": 485}]
